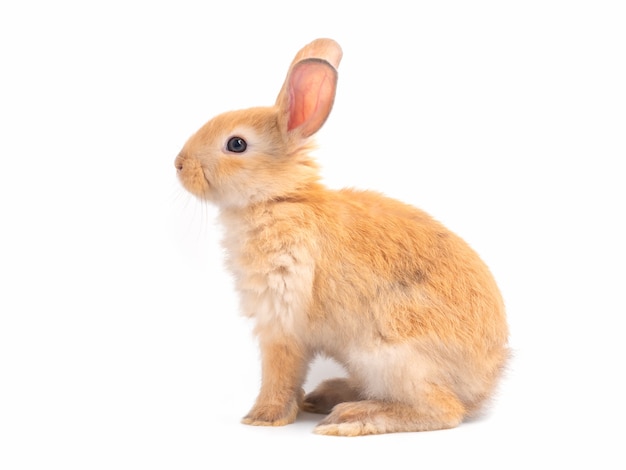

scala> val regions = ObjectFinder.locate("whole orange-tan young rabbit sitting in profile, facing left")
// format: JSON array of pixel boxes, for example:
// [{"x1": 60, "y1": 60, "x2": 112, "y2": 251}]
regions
[{"x1": 175, "y1": 38, "x2": 509, "y2": 436}]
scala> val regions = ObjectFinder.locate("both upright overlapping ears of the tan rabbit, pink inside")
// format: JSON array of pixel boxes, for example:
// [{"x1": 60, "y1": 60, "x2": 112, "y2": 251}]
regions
[{"x1": 276, "y1": 39, "x2": 342, "y2": 137}]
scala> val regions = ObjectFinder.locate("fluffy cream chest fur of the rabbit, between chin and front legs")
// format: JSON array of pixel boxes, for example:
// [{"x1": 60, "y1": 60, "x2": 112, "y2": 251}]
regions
[{"x1": 221, "y1": 208, "x2": 315, "y2": 334}]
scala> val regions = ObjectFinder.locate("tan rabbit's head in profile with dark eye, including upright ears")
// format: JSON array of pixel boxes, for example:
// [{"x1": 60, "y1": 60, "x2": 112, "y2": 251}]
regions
[{"x1": 175, "y1": 39, "x2": 341, "y2": 207}]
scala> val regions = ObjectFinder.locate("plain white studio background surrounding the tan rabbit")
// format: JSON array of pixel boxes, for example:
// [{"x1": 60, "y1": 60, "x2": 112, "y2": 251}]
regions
[{"x1": 0, "y1": 0, "x2": 626, "y2": 470}]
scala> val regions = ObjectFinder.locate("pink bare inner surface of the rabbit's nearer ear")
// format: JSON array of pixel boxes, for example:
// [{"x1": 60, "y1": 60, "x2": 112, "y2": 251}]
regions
[{"x1": 287, "y1": 60, "x2": 337, "y2": 137}]
